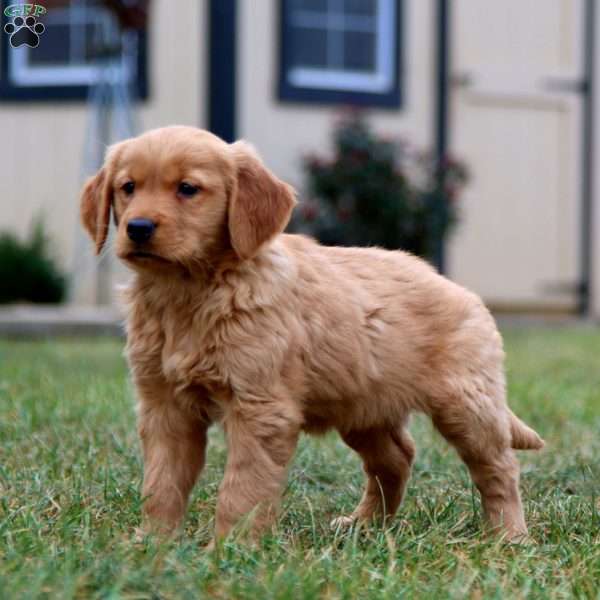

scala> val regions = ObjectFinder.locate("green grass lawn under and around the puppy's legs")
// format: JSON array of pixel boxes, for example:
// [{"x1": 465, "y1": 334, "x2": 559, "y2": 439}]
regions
[{"x1": 0, "y1": 329, "x2": 600, "y2": 600}]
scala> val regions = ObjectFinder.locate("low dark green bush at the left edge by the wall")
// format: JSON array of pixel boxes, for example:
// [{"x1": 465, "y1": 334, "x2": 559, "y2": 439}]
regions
[{"x1": 0, "y1": 221, "x2": 66, "y2": 304}]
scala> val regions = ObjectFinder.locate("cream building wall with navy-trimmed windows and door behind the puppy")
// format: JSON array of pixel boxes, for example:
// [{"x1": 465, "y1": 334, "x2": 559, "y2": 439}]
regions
[{"x1": 0, "y1": 0, "x2": 600, "y2": 316}]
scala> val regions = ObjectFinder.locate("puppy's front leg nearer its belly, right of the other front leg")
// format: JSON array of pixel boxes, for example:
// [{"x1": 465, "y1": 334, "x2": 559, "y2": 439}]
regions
[{"x1": 215, "y1": 399, "x2": 300, "y2": 538}]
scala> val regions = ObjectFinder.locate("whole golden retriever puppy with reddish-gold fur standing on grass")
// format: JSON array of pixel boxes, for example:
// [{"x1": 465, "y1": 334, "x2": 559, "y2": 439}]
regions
[{"x1": 81, "y1": 127, "x2": 543, "y2": 539}]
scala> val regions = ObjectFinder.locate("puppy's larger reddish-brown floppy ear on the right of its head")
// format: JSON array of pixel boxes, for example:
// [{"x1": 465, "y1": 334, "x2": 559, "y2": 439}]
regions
[{"x1": 228, "y1": 142, "x2": 296, "y2": 259}]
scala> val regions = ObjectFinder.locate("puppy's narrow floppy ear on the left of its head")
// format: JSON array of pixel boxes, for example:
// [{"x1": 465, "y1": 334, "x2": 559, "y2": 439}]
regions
[{"x1": 80, "y1": 167, "x2": 113, "y2": 254}]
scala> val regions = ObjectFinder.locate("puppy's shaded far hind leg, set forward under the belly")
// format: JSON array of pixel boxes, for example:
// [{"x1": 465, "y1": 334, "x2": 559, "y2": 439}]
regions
[{"x1": 332, "y1": 427, "x2": 415, "y2": 526}]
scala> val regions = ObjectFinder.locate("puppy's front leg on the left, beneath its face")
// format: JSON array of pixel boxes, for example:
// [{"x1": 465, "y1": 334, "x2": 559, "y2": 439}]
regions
[{"x1": 138, "y1": 380, "x2": 209, "y2": 534}]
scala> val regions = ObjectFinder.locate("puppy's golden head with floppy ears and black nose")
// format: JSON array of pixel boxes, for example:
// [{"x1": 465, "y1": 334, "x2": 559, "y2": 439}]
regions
[{"x1": 81, "y1": 127, "x2": 296, "y2": 269}]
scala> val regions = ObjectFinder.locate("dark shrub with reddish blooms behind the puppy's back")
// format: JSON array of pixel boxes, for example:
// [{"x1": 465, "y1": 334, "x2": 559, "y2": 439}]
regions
[{"x1": 294, "y1": 114, "x2": 467, "y2": 257}]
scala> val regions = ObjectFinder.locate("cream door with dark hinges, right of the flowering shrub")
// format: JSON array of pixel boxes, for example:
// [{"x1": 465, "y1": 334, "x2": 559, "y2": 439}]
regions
[{"x1": 448, "y1": 0, "x2": 584, "y2": 310}]
